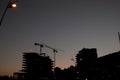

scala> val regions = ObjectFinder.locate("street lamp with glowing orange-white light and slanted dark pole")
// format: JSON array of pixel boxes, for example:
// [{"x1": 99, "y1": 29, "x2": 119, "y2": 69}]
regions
[{"x1": 0, "y1": 0, "x2": 17, "y2": 27}]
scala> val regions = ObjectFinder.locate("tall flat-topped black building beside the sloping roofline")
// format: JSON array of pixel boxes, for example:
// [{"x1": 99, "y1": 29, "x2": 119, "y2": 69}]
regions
[{"x1": 76, "y1": 48, "x2": 97, "y2": 80}]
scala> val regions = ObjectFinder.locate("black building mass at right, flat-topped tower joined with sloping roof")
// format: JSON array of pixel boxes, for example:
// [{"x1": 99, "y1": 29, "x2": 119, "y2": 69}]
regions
[{"x1": 76, "y1": 48, "x2": 120, "y2": 80}]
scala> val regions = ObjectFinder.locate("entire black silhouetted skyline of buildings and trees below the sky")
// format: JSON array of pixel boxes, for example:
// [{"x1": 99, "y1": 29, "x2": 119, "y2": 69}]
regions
[{"x1": 13, "y1": 48, "x2": 120, "y2": 80}]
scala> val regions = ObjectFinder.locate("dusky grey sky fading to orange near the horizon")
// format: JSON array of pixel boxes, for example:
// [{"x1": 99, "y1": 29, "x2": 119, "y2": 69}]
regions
[{"x1": 0, "y1": 0, "x2": 120, "y2": 75}]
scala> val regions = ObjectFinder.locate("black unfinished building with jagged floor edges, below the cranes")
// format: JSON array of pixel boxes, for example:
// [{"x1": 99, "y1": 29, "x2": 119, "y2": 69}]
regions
[{"x1": 13, "y1": 52, "x2": 53, "y2": 80}]
